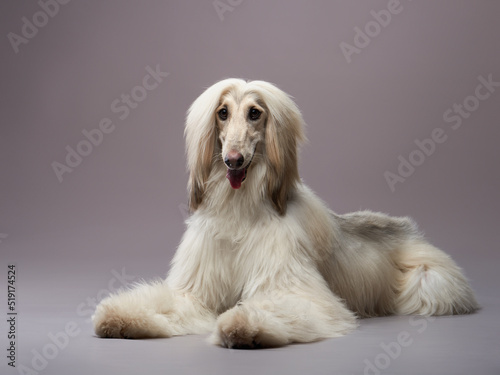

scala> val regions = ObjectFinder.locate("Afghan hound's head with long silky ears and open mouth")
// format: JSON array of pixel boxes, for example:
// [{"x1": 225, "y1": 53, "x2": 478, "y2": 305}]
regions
[{"x1": 185, "y1": 79, "x2": 304, "y2": 214}]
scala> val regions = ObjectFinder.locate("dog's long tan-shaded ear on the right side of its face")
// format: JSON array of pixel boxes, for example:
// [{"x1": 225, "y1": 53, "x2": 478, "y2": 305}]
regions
[{"x1": 252, "y1": 81, "x2": 305, "y2": 215}]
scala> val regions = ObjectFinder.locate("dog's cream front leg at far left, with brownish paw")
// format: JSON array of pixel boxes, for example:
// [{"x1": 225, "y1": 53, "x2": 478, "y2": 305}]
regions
[{"x1": 92, "y1": 282, "x2": 215, "y2": 339}]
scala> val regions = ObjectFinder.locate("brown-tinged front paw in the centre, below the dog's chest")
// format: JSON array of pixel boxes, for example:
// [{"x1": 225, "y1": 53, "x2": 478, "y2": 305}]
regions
[{"x1": 211, "y1": 306, "x2": 288, "y2": 349}]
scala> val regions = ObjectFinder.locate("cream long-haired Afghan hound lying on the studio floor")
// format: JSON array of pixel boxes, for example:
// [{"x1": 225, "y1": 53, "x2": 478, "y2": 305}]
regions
[{"x1": 93, "y1": 79, "x2": 478, "y2": 349}]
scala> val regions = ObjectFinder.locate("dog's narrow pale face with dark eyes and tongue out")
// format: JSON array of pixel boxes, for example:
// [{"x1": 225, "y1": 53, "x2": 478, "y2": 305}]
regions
[{"x1": 216, "y1": 92, "x2": 267, "y2": 189}]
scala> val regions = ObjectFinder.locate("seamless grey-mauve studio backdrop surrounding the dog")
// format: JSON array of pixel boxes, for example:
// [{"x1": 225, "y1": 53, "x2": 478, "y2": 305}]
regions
[{"x1": 0, "y1": 0, "x2": 500, "y2": 374}]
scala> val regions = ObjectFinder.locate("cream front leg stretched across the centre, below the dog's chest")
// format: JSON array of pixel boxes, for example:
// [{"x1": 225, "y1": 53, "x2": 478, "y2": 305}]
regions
[{"x1": 210, "y1": 285, "x2": 356, "y2": 349}]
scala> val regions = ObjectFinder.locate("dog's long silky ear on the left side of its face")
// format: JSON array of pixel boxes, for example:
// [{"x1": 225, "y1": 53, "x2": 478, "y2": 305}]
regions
[{"x1": 184, "y1": 79, "x2": 244, "y2": 211}]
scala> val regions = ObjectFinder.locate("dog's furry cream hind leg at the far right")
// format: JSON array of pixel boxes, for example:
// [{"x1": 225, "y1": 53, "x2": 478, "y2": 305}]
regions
[{"x1": 393, "y1": 240, "x2": 478, "y2": 315}]
